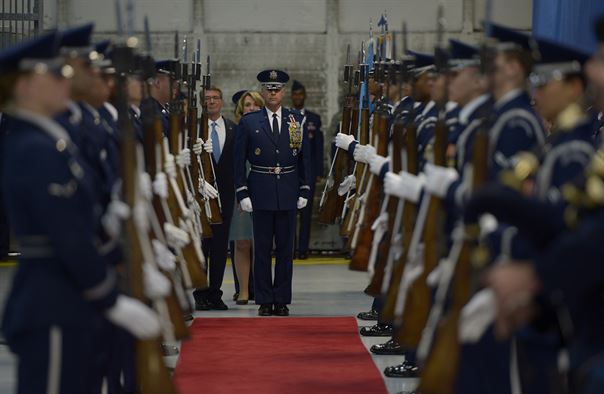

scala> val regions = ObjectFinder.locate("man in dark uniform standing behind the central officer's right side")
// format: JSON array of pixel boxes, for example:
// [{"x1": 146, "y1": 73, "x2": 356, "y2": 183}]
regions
[{"x1": 291, "y1": 81, "x2": 324, "y2": 260}]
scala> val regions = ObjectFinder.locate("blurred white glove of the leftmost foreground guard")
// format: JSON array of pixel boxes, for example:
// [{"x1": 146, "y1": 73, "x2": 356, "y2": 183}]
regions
[{"x1": 105, "y1": 295, "x2": 161, "y2": 339}]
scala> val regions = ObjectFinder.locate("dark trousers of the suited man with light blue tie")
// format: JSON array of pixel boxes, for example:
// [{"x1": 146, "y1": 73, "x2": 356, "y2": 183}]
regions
[{"x1": 199, "y1": 215, "x2": 231, "y2": 302}]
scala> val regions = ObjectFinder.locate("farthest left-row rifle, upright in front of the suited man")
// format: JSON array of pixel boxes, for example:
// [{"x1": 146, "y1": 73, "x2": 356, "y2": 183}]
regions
[{"x1": 200, "y1": 56, "x2": 222, "y2": 224}]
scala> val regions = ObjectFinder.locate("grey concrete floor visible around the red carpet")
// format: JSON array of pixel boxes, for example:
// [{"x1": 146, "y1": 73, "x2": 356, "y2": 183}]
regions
[{"x1": 0, "y1": 258, "x2": 417, "y2": 394}]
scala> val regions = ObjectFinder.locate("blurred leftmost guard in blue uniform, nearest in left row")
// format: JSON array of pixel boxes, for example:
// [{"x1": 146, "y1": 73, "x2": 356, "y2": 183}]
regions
[{"x1": 0, "y1": 32, "x2": 160, "y2": 394}]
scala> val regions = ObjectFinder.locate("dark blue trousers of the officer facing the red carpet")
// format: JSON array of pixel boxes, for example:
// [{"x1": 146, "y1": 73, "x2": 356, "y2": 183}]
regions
[{"x1": 252, "y1": 209, "x2": 296, "y2": 304}]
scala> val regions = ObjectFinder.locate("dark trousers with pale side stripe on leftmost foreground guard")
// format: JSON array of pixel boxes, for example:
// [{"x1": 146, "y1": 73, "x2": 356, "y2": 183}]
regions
[{"x1": 10, "y1": 326, "x2": 101, "y2": 394}]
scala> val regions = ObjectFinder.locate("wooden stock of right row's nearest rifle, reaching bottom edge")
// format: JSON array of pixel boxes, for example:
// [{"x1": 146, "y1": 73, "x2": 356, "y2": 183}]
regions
[{"x1": 418, "y1": 127, "x2": 488, "y2": 394}]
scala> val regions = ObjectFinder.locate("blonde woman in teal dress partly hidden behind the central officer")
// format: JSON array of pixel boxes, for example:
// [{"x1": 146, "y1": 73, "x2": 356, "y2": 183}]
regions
[{"x1": 229, "y1": 91, "x2": 264, "y2": 305}]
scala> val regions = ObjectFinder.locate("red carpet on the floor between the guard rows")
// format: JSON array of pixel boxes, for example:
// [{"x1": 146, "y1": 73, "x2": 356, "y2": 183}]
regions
[{"x1": 175, "y1": 317, "x2": 387, "y2": 394}]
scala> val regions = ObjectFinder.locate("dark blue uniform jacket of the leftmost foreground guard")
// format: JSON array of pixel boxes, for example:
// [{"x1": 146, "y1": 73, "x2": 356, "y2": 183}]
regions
[{"x1": 2, "y1": 114, "x2": 117, "y2": 343}]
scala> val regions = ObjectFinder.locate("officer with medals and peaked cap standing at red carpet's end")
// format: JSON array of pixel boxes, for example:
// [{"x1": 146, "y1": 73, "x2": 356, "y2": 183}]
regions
[{"x1": 235, "y1": 70, "x2": 312, "y2": 316}]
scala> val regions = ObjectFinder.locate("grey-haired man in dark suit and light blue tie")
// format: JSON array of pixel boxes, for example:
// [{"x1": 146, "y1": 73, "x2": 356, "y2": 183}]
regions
[{"x1": 193, "y1": 86, "x2": 235, "y2": 310}]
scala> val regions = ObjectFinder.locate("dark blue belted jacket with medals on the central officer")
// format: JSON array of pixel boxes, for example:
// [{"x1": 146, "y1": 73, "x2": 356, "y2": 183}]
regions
[{"x1": 235, "y1": 107, "x2": 311, "y2": 211}]
